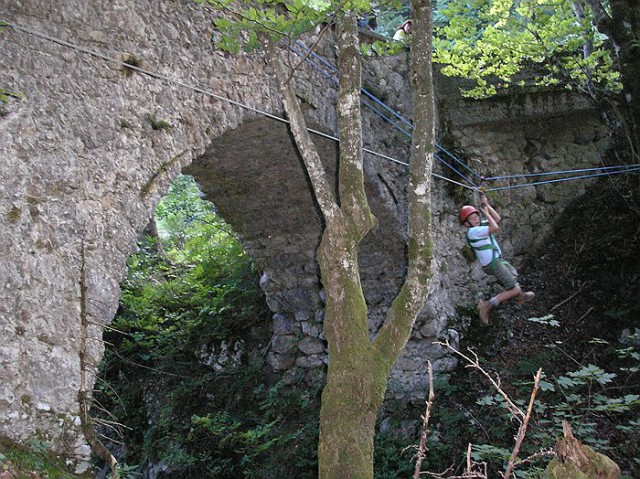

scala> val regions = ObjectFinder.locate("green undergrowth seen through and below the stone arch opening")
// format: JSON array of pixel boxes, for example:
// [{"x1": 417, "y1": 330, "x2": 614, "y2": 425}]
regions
[{"x1": 95, "y1": 176, "x2": 319, "y2": 479}]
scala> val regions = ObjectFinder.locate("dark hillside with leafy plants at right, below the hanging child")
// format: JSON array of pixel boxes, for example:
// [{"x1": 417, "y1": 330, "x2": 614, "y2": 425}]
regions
[{"x1": 428, "y1": 179, "x2": 640, "y2": 477}]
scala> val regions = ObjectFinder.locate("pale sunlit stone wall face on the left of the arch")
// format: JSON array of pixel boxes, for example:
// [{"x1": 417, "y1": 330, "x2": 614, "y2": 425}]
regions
[{"x1": 0, "y1": 0, "x2": 292, "y2": 468}]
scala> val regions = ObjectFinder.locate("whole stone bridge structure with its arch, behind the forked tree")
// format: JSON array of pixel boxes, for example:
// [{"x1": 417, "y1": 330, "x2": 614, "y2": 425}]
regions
[{"x1": 0, "y1": 0, "x2": 606, "y2": 468}]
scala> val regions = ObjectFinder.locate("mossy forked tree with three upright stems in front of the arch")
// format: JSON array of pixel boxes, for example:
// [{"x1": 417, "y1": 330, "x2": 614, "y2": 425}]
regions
[{"x1": 268, "y1": 0, "x2": 435, "y2": 479}]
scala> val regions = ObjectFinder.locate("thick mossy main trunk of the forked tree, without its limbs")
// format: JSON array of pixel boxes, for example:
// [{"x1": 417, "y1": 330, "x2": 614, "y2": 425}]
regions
[{"x1": 318, "y1": 225, "x2": 388, "y2": 479}]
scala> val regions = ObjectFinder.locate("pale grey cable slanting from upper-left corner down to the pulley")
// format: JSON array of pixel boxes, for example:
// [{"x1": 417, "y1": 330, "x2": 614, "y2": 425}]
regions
[{"x1": 5, "y1": 20, "x2": 471, "y2": 189}]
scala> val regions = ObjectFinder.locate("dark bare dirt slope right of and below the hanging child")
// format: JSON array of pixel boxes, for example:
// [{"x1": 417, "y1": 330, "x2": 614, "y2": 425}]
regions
[{"x1": 454, "y1": 178, "x2": 640, "y2": 477}]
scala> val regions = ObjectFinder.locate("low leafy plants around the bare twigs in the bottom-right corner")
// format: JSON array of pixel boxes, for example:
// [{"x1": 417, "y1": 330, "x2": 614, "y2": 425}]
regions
[{"x1": 420, "y1": 318, "x2": 640, "y2": 479}]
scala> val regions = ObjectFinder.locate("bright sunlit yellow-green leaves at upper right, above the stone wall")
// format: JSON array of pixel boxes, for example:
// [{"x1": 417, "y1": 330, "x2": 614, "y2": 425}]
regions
[{"x1": 433, "y1": 0, "x2": 621, "y2": 98}]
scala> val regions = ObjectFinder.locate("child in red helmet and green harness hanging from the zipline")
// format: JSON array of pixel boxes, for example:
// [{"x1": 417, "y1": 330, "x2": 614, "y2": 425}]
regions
[{"x1": 459, "y1": 192, "x2": 535, "y2": 325}]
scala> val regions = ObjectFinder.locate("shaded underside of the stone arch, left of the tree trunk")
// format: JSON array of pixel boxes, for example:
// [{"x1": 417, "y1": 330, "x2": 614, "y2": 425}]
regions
[{"x1": 183, "y1": 118, "x2": 337, "y2": 371}]
